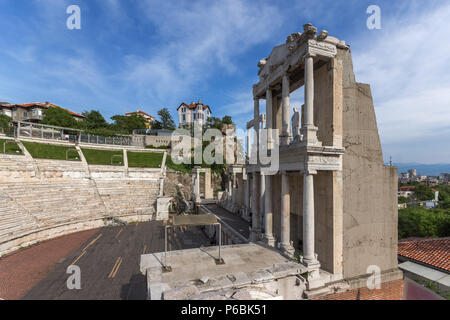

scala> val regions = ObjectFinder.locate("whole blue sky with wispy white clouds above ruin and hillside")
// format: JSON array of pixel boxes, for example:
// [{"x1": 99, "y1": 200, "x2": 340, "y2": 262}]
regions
[{"x1": 0, "y1": 0, "x2": 450, "y2": 163}]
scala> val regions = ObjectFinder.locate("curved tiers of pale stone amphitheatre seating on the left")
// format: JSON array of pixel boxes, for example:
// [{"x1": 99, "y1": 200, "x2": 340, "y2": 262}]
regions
[{"x1": 0, "y1": 155, "x2": 161, "y2": 255}]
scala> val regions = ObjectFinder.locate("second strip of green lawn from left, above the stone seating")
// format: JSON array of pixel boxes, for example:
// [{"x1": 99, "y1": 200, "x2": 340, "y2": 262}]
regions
[{"x1": 22, "y1": 141, "x2": 81, "y2": 161}]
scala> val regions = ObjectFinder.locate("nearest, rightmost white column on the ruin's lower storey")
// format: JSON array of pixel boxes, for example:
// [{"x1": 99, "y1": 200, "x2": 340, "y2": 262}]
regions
[{"x1": 303, "y1": 170, "x2": 318, "y2": 266}]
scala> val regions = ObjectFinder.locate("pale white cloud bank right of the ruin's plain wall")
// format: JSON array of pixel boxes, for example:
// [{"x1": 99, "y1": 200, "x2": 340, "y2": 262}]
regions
[{"x1": 353, "y1": 4, "x2": 450, "y2": 162}]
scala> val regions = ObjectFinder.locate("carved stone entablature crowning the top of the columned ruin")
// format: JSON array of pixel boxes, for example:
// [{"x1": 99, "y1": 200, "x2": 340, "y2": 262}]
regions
[{"x1": 253, "y1": 24, "x2": 342, "y2": 97}]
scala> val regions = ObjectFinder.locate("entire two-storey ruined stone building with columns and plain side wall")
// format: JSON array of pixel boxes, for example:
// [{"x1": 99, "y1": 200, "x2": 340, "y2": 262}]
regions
[{"x1": 227, "y1": 24, "x2": 401, "y2": 287}]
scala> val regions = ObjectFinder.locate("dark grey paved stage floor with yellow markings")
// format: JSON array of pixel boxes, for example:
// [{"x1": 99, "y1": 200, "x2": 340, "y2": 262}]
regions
[{"x1": 10, "y1": 221, "x2": 210, "y2": 300}]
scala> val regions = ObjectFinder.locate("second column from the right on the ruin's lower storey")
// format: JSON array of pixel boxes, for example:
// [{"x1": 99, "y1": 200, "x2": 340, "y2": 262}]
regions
[{"x1": 280, "y1": 171, "x2": 295, "y2": 256}]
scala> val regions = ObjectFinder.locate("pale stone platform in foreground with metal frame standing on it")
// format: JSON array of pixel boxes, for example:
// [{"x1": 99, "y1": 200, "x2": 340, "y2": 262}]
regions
[{"x1": 140, "y1": 243, "x2": 306, "y2": 300}]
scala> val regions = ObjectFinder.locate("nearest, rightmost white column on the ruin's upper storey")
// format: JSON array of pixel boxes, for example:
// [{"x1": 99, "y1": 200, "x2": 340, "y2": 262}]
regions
[{"x1": 302, "y1": 54, "x2": 318, "y2": 145}]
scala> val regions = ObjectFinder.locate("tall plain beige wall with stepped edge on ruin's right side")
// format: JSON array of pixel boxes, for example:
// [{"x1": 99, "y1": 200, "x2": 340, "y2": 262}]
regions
[{"x1": 338, "y1": 50, "x2": 398, "y2": 277}]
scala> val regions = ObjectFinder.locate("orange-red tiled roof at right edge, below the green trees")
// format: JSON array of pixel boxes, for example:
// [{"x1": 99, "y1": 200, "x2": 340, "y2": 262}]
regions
[{"x1": 398, "y1": 237, "x2": 450, "y2": 272}]
